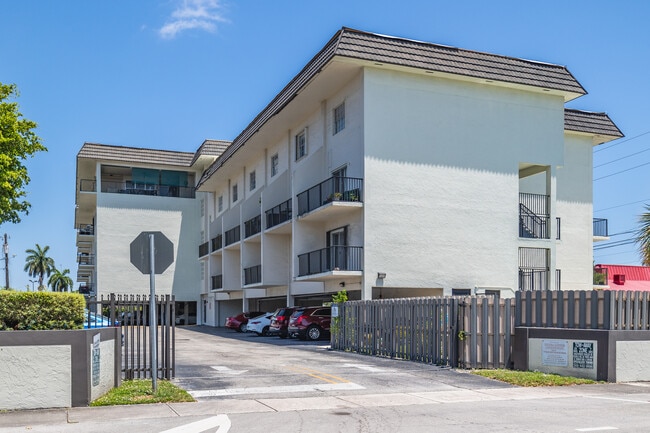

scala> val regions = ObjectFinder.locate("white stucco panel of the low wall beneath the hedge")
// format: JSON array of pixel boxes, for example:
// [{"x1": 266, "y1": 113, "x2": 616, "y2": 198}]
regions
[{"x1": 0, "y1": 345, "x2": 72, "y2": 410}]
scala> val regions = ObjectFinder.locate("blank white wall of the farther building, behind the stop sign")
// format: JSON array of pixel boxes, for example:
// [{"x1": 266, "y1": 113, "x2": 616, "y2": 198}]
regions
[{"x1": 95, "y1": 194, "x2": 200, "y2": 301}]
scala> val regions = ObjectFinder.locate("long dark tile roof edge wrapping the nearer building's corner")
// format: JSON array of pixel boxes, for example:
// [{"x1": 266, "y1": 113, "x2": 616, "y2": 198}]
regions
[{"x1": 197, "y1": 27, "x2": 587, "y2": 188}]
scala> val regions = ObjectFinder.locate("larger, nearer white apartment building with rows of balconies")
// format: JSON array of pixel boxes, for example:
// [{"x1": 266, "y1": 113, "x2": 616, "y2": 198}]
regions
[{"x1": 194, "y1": 28, "x2": 622, "y2": 325}]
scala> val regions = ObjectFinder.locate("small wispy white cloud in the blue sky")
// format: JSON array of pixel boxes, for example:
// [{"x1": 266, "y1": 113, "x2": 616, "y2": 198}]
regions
[{"x1": 158, "y1": 0, "x2": 226, "y2": 39}]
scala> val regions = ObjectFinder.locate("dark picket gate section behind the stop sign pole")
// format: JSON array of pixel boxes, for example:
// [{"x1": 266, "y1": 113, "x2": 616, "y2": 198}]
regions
[{"x1": 86, "y1": 294, "x2": 176, "y2": 380}]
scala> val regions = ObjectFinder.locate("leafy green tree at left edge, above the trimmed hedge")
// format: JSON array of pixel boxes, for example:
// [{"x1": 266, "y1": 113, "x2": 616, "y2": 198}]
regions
[{"x1": 0, "y1": 83, "x2": 47, "y2": 224}]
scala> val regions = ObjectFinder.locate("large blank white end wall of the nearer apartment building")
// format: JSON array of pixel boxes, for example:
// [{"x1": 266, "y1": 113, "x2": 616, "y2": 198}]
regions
[{"x1": 364, "y1": 69, "x2": 564, "y2": 298}]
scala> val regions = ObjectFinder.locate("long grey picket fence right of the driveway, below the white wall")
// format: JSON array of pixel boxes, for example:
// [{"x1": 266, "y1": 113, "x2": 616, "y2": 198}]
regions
[{"x1": 331, "y1": 290, "x2": 650, "y2": 368}]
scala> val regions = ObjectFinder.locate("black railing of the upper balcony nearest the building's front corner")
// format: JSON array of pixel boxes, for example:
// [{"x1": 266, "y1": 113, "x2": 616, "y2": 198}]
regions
[{"x1": 298, "y1": 177, "x2": 363, "y2": 215}]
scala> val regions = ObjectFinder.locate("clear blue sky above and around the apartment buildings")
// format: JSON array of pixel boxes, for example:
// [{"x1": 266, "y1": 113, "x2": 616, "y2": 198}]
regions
[{"x1": 0, "y1": 0, "x2": 650, "y2": 289}]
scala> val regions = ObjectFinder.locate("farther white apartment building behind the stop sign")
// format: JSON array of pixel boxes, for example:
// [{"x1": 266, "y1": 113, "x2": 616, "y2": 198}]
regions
[{"x1": 75, "y1": 140, "x2": 230, "y2": 317}]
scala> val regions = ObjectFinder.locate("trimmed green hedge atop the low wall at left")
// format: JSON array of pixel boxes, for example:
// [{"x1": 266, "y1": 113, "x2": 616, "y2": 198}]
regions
[{"x1": 0, "y1": 290, "x2": 86, "y2": 331}]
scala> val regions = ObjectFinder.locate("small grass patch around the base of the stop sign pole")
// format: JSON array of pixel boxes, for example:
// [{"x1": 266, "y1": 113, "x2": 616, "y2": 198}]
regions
[{"x1": 90, "y1": 379, "x2": 194, "y2": 406}]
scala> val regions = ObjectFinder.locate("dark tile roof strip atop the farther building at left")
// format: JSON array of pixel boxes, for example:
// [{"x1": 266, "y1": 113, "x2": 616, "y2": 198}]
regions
[{"x1": 77, "y1": 143, "x2": 194, "y2": 167}]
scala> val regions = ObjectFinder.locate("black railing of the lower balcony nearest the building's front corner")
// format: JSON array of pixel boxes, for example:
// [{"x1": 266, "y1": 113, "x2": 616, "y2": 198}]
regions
[{"x1": 298, "y1": 246, "x2": 363, "y2": 276}]
